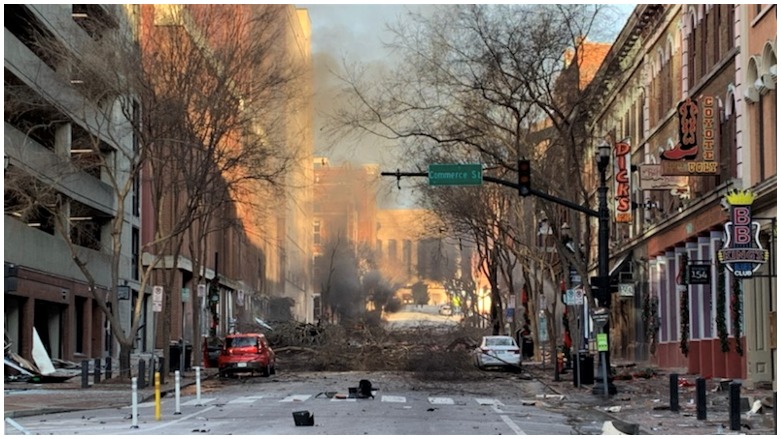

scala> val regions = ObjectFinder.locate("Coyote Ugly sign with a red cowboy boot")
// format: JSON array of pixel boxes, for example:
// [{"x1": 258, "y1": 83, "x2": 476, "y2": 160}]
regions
[{"x1": 661, "y1": 96, "x2": 719, "y2": 176}]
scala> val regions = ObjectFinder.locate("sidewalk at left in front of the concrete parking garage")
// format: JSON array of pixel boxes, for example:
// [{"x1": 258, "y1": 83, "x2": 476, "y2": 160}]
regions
[{"x1": 3, "y1": 369, "x2": 217, "y2": 418}]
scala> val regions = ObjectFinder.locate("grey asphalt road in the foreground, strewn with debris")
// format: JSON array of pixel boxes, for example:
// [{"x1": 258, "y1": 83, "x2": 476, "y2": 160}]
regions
[{"x1": 6, "y1": 372, "x2": 576, "y2": 435}]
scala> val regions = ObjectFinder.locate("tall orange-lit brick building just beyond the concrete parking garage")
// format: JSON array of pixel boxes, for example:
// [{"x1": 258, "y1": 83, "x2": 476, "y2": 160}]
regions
[{"x1": 141, "y1": 5, "x2": 313, "y2": 347}]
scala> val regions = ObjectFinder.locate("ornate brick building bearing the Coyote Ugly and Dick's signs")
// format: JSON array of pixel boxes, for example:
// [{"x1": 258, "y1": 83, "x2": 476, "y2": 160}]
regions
[{"x1": 588, "y1": 5, "x2": 776, "y2": 388}]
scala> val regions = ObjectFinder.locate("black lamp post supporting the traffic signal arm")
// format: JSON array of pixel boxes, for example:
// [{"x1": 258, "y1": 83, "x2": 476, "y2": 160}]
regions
[{"x1": 592, "y1": 140, "x2": 616, "y2": 395}]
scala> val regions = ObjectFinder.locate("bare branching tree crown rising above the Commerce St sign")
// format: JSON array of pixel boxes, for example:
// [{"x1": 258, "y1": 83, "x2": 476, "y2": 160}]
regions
[{"x1": 324, "y1": 5, "x2": 616, "y2": 348}]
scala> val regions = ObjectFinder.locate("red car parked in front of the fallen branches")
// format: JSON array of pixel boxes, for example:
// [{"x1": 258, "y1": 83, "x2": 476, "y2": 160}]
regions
[{"x1": 217, "y1": 334, "x2": 276, "y2": 377}]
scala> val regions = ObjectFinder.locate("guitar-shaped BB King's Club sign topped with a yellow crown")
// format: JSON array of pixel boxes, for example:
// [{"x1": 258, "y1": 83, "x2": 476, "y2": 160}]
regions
[{"x1": 718, "y1": 190, "x2": 768, "y2": 277}]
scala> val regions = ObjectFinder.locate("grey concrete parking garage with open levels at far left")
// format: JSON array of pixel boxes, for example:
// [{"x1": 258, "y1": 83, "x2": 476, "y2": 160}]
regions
[{"x1": 3, "y1": 4, "x2": 142, "y2": 361}]
